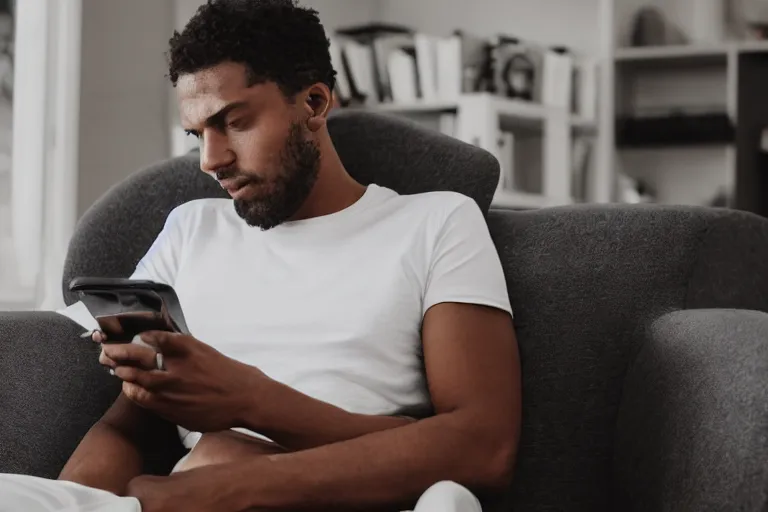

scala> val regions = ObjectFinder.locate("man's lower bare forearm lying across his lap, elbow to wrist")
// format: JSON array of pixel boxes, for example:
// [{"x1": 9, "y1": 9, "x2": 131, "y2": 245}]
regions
[{"x1": 225, "y1": 411, "x2": 515, "y2": 511}]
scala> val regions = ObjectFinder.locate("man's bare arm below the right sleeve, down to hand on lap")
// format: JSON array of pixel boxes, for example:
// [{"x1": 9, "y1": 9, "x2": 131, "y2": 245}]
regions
[{"x1": 131, "y1": 303, "x2": 521, "y2": 511}]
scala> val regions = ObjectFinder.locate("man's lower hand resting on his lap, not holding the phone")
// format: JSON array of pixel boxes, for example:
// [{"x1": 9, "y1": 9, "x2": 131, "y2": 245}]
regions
[{"x1": 126, "y1": 465, "x2": 243, "y2": 512}]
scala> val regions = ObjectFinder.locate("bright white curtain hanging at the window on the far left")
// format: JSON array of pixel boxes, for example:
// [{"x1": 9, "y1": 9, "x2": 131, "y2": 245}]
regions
[{"x1": 11, "y1": 0, "x2": 82, "y2": 309}]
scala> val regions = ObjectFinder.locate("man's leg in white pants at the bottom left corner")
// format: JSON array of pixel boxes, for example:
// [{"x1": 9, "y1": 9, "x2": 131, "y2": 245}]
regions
[{"x1": 0, "y1": 474, "x2": 141, "y2": 512}]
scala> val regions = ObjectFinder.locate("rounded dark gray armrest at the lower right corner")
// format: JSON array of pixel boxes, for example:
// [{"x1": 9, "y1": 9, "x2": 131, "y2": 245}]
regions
[{"x1": 614, "y1": 310, "x2": 768, "y2": 511}]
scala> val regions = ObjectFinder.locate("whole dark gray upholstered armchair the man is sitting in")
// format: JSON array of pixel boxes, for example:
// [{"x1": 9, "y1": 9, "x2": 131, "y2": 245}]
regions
[{"x1": 0, "y1": 112, "x2": 768, "y2": 511}]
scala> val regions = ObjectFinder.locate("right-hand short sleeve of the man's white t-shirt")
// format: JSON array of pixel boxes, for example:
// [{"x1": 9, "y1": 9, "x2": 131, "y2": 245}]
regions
[{"x1": 423, "y1": 199, "x2": 512, "y2": 314}]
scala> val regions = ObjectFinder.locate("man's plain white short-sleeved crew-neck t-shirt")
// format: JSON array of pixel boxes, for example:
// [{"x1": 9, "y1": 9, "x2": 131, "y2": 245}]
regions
[{"x1": 58, "y1": 185, "x2": 511, "y2": 446}]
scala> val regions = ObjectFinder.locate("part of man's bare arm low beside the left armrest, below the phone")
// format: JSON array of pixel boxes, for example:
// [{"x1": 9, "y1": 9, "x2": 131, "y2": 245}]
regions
[{"x1": 59, "y1": 422, "x2": 142, "y2": 495}]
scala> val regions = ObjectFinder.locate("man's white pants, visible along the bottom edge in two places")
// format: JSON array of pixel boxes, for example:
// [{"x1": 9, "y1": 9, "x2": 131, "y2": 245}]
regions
[{"x1": 0, "y1": 474, "x2": 482, "y2": 512}]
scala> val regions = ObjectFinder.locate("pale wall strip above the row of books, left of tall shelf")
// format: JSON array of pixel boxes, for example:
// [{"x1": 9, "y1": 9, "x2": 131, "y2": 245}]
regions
[{"x1": 380, "y1": 0, "x2": 600, "y2": 54}]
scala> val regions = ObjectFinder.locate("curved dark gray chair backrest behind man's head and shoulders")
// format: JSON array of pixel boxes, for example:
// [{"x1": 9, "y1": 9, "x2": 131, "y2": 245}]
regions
[{"x1": 63, "y1": 111, "x2": 499, "y2": 304}]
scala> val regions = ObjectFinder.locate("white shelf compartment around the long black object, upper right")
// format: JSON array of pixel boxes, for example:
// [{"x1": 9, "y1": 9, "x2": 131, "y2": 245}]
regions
[{"x1": 614, "y1": 36, "x2": 768, "y2": 205}]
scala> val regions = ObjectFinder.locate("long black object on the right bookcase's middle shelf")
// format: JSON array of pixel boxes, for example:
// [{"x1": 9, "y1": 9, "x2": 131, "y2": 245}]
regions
[{"x1": 616, "y1": 113, "x2": 736, "y2": 148}]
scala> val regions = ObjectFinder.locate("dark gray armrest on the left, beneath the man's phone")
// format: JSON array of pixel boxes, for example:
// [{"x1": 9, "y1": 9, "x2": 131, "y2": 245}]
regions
[{"x1": 0, "y1": 312, "x2": 182, "y2": 478}]
